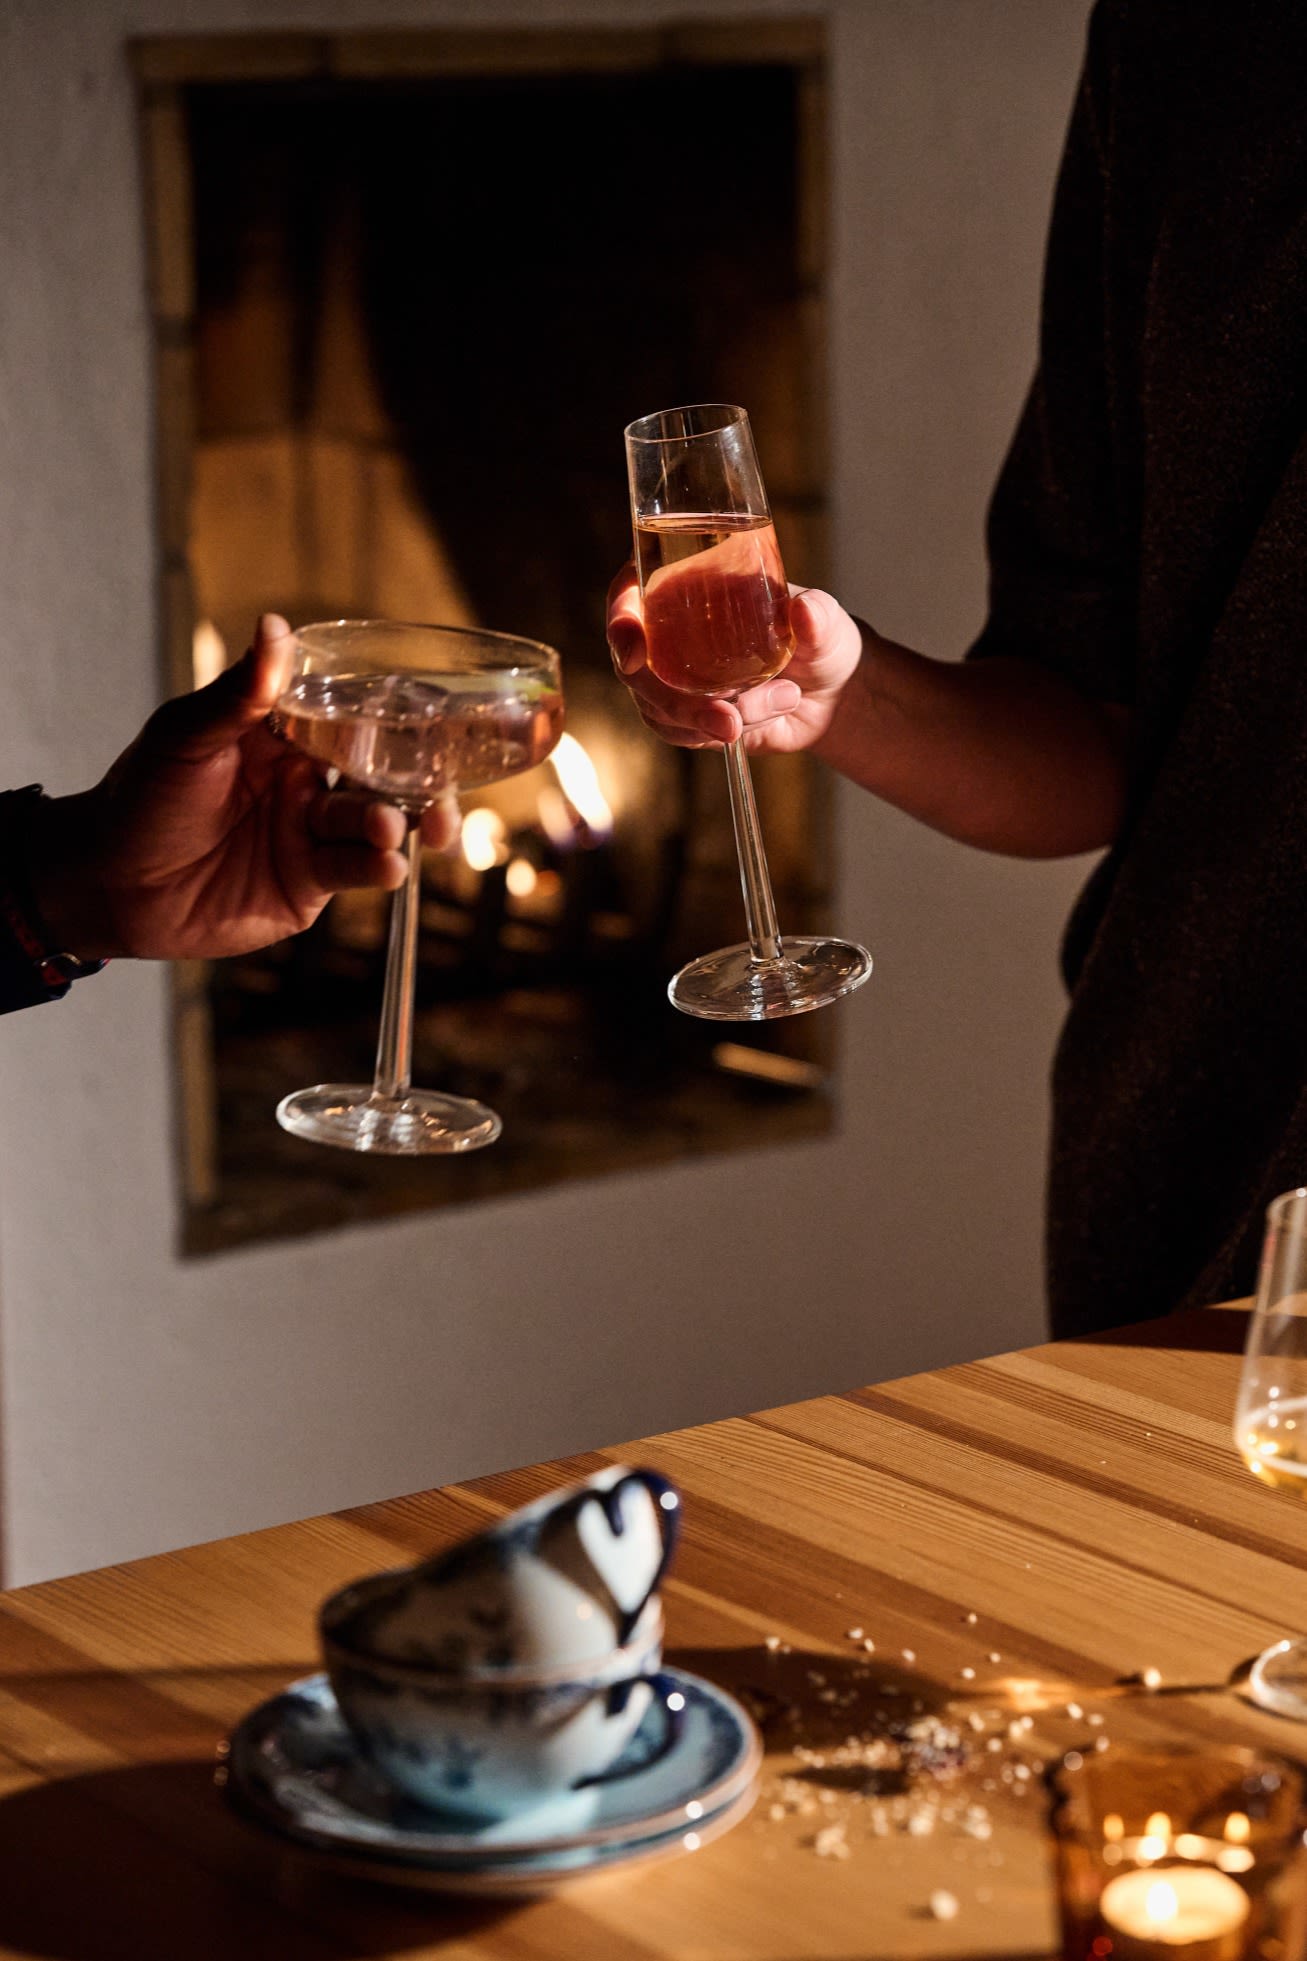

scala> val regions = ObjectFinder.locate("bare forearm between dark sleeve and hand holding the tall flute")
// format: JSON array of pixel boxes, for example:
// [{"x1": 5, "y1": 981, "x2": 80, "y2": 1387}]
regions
[{"x1": 816, "y1": 628, "x2": 1128, "y2": 859}]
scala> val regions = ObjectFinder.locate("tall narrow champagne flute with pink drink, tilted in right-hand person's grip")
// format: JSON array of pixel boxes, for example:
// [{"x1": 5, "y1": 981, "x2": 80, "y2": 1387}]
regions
[{"x1": 626, "y1": 402, "x2": 871, "y2": 1022}]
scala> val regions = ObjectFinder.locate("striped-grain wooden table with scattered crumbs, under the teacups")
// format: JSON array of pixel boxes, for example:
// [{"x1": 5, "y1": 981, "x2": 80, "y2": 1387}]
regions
[{"x1": 0, "y1": 1312, "x2": 1307, "y2": 1961}]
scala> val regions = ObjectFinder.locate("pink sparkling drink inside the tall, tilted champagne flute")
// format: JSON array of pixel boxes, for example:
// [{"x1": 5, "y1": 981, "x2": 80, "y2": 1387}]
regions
[{"x1": 636, "y1": 512, "x2": 795, "y2": 696}]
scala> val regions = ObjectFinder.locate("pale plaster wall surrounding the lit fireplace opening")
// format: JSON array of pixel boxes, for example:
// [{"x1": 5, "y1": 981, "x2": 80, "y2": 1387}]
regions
[{"x1": 0, "y1": 0, "x2": 1085, "y2": 1583}]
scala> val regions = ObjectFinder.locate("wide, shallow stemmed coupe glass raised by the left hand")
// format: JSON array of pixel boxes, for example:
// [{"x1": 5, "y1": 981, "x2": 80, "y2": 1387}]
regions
[{"x1": 273, "y1": 620, "x2": 563, "y2": 1157}]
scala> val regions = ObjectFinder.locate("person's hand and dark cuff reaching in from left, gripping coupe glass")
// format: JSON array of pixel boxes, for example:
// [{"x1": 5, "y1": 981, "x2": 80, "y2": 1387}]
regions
[{"x1": 0, "y1": 614, "x2": 451, "y2": 1014}]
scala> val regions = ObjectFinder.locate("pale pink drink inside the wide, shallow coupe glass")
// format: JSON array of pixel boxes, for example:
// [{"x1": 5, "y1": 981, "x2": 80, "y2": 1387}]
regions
[{"x1": 275, "y1": 673, "x2": 563, "y2": 810}]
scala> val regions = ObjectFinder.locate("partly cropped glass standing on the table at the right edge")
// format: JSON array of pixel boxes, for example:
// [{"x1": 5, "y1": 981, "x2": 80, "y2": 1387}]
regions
[{"x1": 1234, "y1": 1186, "x2": 1307, "y2": 1722}]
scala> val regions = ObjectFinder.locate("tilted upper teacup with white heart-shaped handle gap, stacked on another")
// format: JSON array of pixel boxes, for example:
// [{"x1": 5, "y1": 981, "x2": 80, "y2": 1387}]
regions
[{"x1": 322, "y1": 1465, "x2": 679, "y2": 1675}]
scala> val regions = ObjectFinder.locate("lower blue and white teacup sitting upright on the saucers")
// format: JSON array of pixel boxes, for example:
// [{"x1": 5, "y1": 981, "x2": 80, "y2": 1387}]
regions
[{"x1": 322, "y1": 1573, "x2": 681, "y2": 1820}]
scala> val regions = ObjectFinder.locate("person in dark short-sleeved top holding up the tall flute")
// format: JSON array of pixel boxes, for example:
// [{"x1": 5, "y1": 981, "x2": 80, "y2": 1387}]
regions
[{"x1": 610, "y1": 0, "x2": 1307, "y2": 1335}]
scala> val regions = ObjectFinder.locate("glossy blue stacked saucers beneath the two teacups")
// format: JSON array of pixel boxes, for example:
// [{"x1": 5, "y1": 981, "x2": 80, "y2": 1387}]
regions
[{"x1": 224, "y1": 1669, "x2": 761, "y2": 1892}]
